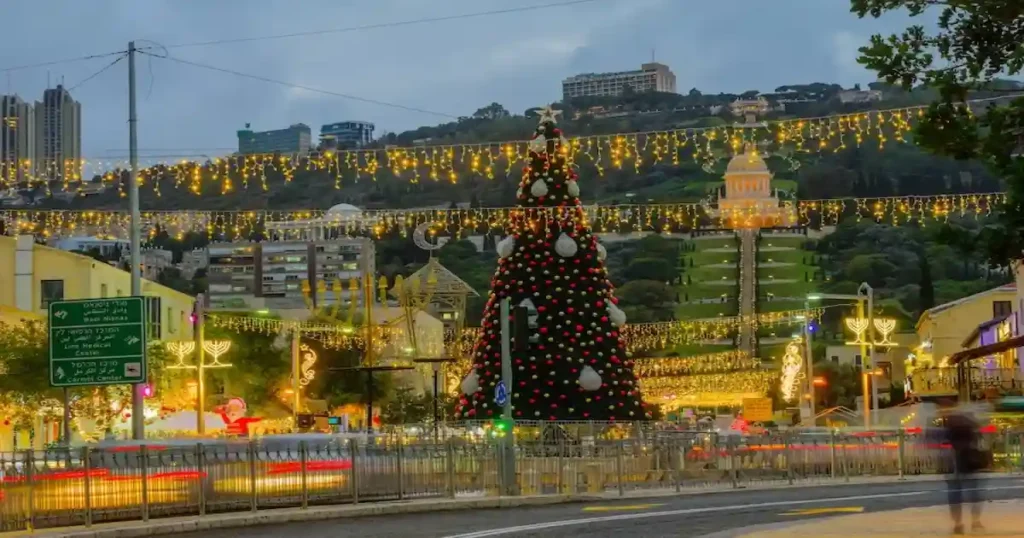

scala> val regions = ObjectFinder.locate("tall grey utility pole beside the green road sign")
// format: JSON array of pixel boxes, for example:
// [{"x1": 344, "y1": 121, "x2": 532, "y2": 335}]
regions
[{"x1": 128, "y1": 41, "x2": 145, "y2": 440}]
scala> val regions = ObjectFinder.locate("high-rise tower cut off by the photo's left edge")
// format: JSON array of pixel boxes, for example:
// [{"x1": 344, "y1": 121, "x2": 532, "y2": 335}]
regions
[{"x1": 0, "y1": 95, "x2": 36, "y2": 182}]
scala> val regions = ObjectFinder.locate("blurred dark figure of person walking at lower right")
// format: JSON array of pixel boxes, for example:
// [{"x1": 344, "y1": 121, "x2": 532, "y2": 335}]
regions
[{"x1": 940, "y1": 401, "x2": 987, "y2": 534}]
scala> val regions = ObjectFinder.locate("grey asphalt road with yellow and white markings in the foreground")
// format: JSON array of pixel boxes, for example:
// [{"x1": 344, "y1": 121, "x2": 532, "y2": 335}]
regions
[{"x1": 167, "y1": 479, "x2": 1024, "y2": 538}]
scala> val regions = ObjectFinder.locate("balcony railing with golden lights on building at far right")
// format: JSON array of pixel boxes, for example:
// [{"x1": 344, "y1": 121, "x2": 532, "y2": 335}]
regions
[{"x1": 908, "y1": 367, "x2": 1024, "y2": 398}]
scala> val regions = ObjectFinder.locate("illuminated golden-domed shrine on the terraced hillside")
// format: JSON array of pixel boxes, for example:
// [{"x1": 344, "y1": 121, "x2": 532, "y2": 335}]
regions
[{"x1": 713, "y1": 144, "x2": 796, "y2": 229}]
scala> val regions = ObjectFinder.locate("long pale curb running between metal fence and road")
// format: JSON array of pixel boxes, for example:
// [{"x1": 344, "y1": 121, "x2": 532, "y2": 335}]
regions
[{"x1": 16, "y1": 473, "x2": 1019, "y2": 538}]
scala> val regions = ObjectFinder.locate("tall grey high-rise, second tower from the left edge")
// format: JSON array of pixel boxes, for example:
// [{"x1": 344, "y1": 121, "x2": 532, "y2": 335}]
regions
[{"x1": 36, "y1": 85, "x2": 82, "y2": 180}]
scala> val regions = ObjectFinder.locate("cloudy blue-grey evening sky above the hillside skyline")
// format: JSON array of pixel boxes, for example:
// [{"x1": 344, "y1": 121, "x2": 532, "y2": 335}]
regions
[{"x1": 0, "y1": 0, "x2": 921, "y2": 159}]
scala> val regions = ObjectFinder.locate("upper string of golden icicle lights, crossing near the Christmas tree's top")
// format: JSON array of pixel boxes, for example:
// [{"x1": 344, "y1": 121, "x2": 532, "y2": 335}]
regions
[{"x1": 0, "y1": 95, "x2": 1013, "y2": 196}]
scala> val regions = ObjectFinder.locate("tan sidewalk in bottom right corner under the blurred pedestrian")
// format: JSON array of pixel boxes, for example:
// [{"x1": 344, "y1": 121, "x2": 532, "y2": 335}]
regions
[{"x1": 733, "y1": 500, "x2": 1024, "y2": 538}]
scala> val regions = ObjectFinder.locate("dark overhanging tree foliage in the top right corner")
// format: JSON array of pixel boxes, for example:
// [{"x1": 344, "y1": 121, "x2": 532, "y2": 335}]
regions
[{"x1": 851, "y1": 0, "x2": 1024, "y2": 264}]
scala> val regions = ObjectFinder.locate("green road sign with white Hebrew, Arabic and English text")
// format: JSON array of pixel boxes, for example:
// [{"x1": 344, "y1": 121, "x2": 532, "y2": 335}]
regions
[{"x1": 49, "y1": 297, "x2": 146, "y2": 386}]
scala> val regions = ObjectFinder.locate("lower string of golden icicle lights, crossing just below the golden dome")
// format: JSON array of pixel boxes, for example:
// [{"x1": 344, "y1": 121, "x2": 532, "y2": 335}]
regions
[{"x1": 0, "y1": 193, "x2": 1006, "y2": 237}]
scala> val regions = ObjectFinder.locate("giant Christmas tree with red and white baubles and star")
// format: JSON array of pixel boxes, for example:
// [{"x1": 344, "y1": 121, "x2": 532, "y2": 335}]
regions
[{"x1": 458, "y1": 108, "x2": 648, "y2": 420}]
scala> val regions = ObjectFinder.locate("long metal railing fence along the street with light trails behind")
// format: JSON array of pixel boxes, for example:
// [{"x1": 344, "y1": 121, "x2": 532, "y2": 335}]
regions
[{"x1": 0, "y1": 431, "x2": 1021, "y2": 531}]
